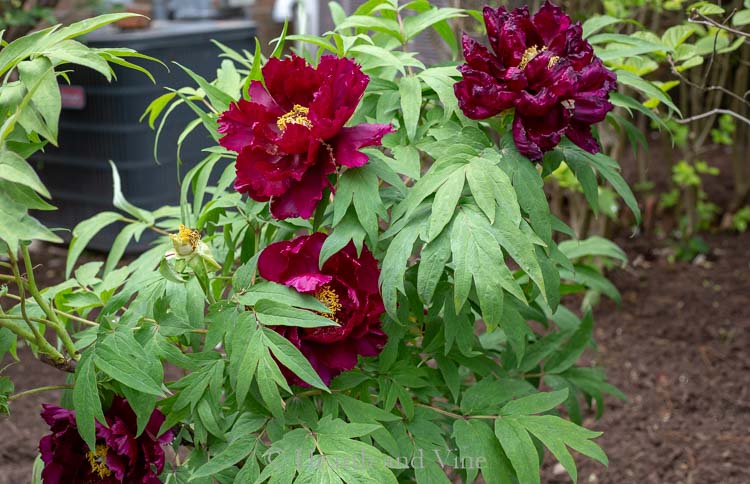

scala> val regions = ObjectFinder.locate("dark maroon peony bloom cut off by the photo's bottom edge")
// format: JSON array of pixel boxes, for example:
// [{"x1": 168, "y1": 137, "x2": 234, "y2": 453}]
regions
[{"x1": 39, "y1": 397, "x2": 174, "y2": 484}]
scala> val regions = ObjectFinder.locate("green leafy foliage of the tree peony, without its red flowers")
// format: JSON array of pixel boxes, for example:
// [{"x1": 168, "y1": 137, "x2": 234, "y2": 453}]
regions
[{"x1": 0, "y1": 0, "x2": 652, "y2": 483}]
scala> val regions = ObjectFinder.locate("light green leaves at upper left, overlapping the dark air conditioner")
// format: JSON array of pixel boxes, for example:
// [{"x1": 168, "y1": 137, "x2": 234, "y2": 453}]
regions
[{"x1": 0, "y1": 14, "x2": 159, "y2": 253}]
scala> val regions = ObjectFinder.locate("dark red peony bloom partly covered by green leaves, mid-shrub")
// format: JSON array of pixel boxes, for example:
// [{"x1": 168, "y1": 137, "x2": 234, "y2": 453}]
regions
[{"x1": 258, "y1": 232, "x2": 388, "y2": 386}]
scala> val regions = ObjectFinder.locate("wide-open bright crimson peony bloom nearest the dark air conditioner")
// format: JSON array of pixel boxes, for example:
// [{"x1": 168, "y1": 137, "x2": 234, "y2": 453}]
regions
[{"x1": 219, "y1": 55, "x2": 393, "y2": 219}]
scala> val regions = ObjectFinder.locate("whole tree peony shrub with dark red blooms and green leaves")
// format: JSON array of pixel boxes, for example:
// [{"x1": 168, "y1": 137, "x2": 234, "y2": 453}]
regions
[{"x1": 0, "y1": 0, "x2": 668, "y2": 483}]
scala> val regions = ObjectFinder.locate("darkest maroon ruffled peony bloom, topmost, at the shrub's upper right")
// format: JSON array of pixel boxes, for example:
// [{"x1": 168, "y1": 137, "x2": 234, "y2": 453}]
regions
[{"x1": 454, "y1": 1, "x2": 617, "y2": 160}]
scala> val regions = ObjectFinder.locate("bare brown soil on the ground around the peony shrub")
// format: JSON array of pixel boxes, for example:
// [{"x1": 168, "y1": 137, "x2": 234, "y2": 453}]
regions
[{"x1": 0, "y1": 233, "x2": 750, "y2": 484}]
